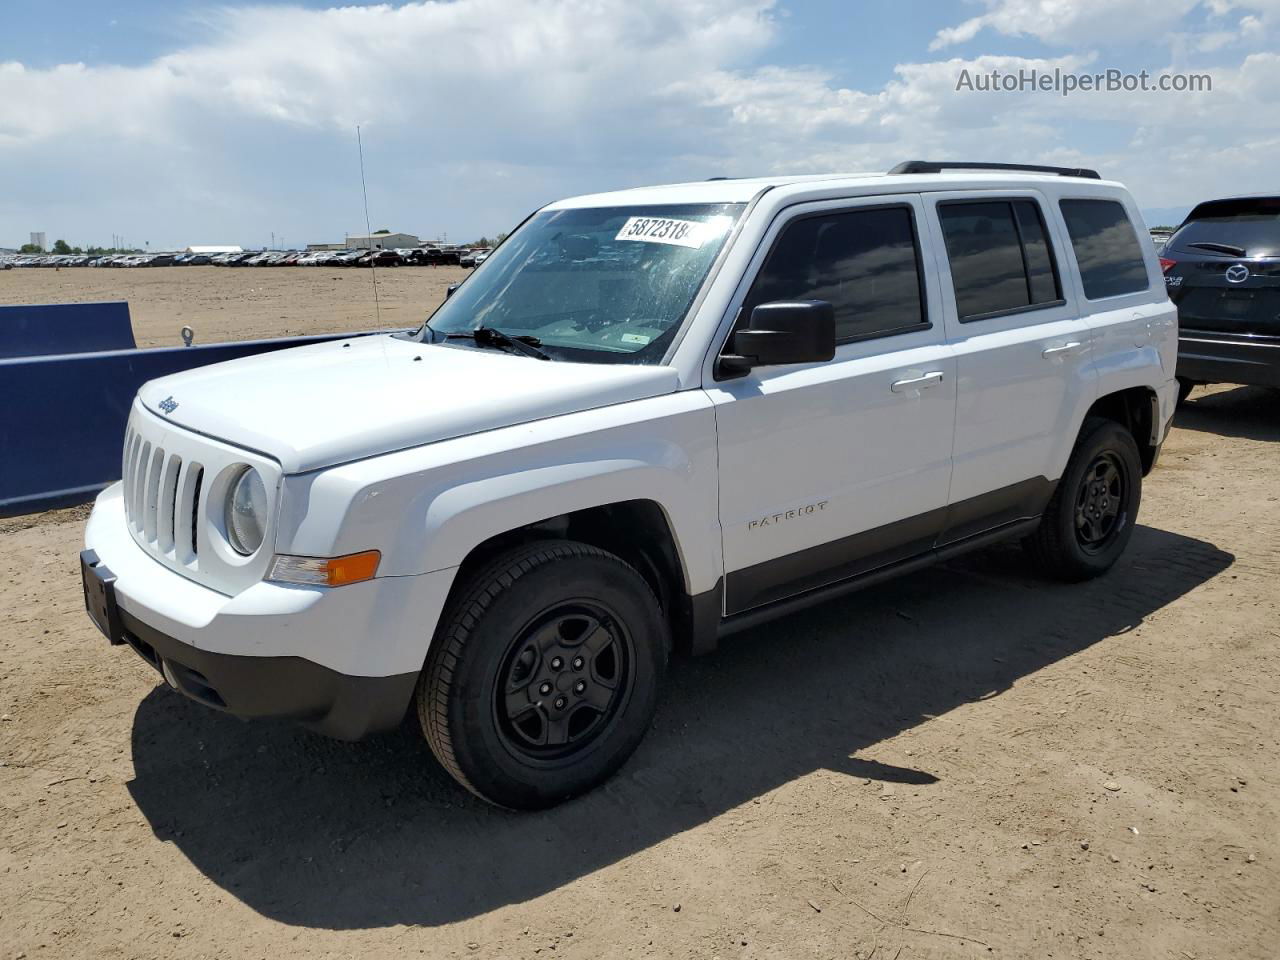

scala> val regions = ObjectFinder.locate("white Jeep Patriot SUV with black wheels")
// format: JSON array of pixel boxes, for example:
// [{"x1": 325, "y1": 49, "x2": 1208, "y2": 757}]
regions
[{"x1": 82, "y1": 161, "x2": 1178, "y2": 808}]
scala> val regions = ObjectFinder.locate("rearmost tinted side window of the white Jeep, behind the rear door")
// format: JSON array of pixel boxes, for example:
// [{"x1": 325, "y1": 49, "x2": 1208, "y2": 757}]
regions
[{"x1": 1061, "y1": 200, "x2": 1149, "y2": 300}]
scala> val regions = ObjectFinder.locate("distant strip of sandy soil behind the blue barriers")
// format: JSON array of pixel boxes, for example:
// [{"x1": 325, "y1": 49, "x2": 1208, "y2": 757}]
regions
[{"x1": 0, "y1": 266, "x2": 471, "y2": 347}]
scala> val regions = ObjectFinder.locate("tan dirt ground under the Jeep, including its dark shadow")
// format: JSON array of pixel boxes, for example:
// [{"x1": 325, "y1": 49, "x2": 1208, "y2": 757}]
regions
[{"x1": 0, "y1": 270, "x2": 1280, "y2": 960}]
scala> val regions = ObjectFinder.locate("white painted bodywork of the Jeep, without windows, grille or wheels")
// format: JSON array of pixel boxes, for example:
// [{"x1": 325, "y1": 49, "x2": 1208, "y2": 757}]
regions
[{"x1": 86, "y1": 172, "x2": 1176, "y2": 676}]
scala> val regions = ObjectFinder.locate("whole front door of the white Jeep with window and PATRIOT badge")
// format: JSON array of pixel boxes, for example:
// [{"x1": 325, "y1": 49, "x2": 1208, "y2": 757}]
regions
[{"x1": 708, "y1": 195, "x2": 956, "y2": 614}]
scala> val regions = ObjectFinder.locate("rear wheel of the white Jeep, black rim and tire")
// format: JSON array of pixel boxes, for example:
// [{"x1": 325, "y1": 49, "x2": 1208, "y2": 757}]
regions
[{"x1": 1023, "y1": 417, "x2": 1142, "y2": 582}]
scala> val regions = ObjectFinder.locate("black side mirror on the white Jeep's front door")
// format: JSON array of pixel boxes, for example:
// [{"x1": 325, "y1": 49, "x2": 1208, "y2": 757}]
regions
[{"x1": 721, "y1": 300, "x2": 836, "y2": 376}]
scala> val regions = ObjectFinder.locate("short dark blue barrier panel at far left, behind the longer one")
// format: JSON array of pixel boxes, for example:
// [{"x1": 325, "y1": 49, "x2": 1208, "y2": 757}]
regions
[{"x1": 0, "y1": 301, "x2": 136, "y2": 358}]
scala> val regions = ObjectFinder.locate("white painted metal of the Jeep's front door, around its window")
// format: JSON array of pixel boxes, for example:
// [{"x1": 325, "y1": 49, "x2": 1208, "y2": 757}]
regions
[{"x1": 707, "y1": 196, "x2": 956, "y2": 586}]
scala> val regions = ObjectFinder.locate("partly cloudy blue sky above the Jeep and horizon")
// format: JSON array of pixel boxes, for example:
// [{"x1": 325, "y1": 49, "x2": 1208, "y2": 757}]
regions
[{"x1": 0, "y1": 0, "x2": 1280, "y2": 250}]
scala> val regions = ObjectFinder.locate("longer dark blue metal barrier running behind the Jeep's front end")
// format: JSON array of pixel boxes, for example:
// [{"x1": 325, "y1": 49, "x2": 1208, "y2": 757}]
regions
[{"x1": 0, "y1": 333, "x2": 394, "y2": 517}]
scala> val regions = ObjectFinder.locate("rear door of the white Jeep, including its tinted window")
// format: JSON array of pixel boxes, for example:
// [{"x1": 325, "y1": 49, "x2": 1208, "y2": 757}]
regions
[{"x1": 927, "y1": 189, "x2": 1096, "y2": 545}]
